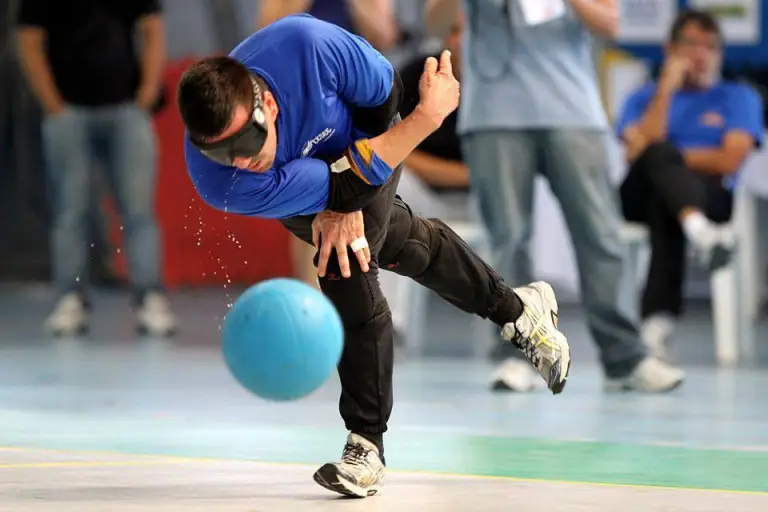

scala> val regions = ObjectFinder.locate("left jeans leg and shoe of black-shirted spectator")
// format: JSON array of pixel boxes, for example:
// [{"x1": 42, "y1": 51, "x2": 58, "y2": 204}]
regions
[{"x1": 43, "y1": 108, "x2": 93, "y2": 335}]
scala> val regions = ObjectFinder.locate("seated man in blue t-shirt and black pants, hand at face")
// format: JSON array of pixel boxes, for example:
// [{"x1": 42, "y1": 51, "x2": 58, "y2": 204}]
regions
[{"x1": 617, "y1": 10, "x2": 764, "y2": 356}]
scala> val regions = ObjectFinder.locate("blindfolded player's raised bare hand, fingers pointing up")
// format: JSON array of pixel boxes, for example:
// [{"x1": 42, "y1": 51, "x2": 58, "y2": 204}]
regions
[{"x1": 419, "y1": 50, "x2": 459, "y2": 126}]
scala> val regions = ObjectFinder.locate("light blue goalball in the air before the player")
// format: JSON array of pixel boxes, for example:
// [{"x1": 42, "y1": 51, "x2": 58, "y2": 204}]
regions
[{"x1": 222, "y1": 279, "x2": 344, "y2": 401}]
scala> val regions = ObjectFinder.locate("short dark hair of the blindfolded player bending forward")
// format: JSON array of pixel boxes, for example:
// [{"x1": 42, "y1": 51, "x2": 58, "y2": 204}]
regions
[{"x1": 177, "y1": 57, "x2": 268, "y2": 141}]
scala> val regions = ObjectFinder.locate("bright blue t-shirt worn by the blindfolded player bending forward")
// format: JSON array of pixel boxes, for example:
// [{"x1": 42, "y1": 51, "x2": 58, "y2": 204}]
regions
[{"x1": 184, "y1": 14, "x2": 394, "y2": 218}]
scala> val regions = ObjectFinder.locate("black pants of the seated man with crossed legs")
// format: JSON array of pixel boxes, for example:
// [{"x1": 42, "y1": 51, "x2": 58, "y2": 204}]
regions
[{"x1": 621, "y1": 143, "x2": 733, "y2": 318}]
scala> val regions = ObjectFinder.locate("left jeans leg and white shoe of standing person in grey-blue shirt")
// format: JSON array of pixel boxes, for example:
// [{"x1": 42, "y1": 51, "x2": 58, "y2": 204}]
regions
[{"x1": 462, "y1": 130, "x2": 541, "y2": 391}]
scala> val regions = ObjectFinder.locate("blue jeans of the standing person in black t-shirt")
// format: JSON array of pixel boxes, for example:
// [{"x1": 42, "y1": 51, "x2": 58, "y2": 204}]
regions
[{"x1": 43, "y1": 103, "x2": 160, "y2": 296}]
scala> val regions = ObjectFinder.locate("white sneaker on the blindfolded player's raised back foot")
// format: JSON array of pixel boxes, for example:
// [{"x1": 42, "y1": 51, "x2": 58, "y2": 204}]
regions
[{"x1": 501, "y1": 281, "x2": 571, "y2": 395}]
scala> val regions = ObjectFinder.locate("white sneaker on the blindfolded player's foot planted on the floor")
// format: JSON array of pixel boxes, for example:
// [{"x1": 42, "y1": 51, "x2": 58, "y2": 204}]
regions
[{"x1": 314, "y1": 434, "x2": 384, "y2": 498}]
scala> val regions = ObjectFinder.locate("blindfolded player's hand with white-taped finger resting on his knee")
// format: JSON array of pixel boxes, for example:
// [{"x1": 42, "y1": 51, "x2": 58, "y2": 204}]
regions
[{"x1": 312, "y1": 211, "x2": 371, "y2": 277}]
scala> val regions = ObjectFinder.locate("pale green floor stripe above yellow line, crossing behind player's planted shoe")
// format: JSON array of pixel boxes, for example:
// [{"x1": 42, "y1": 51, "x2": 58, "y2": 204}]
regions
[{"x1": 8, "y1": 427, "x2": 768, "y2": 493}]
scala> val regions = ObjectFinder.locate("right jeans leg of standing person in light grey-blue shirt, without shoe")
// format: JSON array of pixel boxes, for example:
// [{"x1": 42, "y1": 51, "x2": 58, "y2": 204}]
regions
[{"x1": 545, "y1": 130, "x2": 646, "y2": 378}]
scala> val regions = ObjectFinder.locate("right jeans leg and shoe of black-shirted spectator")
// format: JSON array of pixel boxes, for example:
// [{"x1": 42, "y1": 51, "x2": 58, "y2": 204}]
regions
[{"x1": 99, "y1": 104, "x2": 176, "y2": 335}]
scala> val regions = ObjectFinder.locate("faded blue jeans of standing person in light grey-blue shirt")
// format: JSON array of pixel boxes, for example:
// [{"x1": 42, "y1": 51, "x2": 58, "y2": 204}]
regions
[{"x1": 463, "y1": 130, "x2": 646, "y2": 377}]
